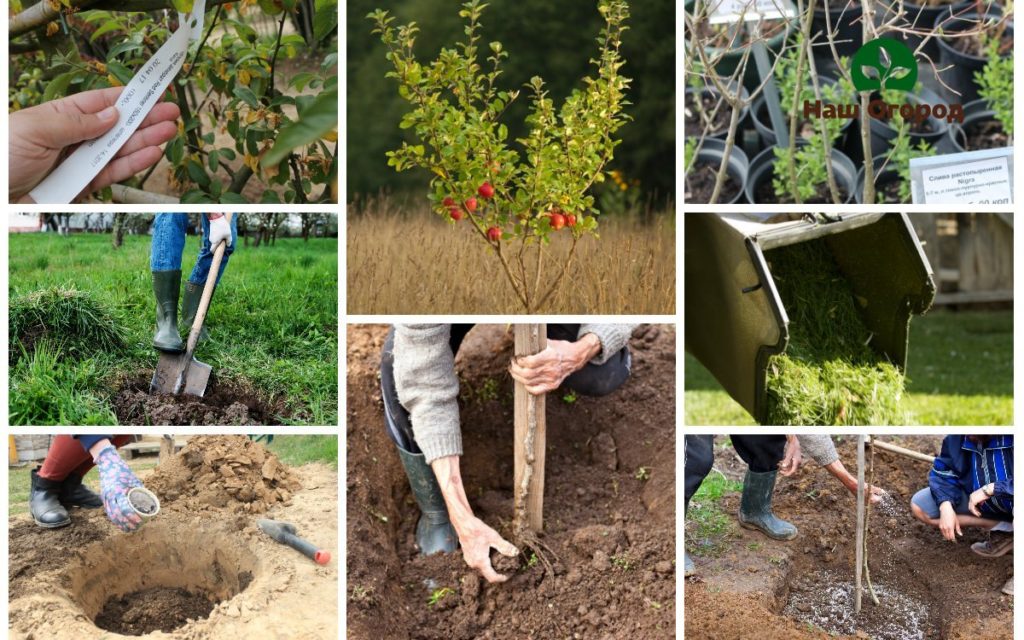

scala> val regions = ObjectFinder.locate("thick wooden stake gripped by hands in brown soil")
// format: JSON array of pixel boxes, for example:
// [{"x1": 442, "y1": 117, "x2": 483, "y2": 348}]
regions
[{"x1": 512, "y1": 325, "x2": 548, "y2": 542}]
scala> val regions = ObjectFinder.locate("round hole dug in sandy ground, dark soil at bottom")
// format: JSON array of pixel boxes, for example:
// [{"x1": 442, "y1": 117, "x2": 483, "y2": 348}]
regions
[{"x1": 67, "y1": 522, "x2": 259, "y2": 636}]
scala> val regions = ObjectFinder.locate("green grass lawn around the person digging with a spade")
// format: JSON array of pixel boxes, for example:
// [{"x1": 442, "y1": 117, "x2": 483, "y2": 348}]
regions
[{"x1": 8, "y1": 233, "x2": 338, "y2": 425}]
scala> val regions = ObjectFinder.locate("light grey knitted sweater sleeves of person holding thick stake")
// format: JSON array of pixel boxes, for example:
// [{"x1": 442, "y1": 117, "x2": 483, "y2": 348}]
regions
[{"x1": 394, "y1": 325, "x2": 636, "y2": 464}]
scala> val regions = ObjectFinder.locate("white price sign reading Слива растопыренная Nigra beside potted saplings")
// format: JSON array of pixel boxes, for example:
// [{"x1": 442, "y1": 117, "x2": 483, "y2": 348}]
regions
[{"x1": 910, "y1": 146, "x2": 1014, "y2": 205}]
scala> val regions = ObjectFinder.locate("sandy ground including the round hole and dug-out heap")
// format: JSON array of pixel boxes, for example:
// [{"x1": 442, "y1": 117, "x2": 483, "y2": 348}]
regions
[{"x1": 8, "y1": 436, "x2": 338, "y2": 640}]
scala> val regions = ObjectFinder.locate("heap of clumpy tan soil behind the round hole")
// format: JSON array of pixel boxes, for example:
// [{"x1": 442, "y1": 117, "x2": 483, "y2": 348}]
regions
[{"x1": 146, "y1": 435, "x2": 302, "y2": 513}]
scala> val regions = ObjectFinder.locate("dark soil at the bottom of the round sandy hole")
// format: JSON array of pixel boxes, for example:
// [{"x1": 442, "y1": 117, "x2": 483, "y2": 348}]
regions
[{"x1": 96, "y1": 587, "x2": 214, "y2": 636}]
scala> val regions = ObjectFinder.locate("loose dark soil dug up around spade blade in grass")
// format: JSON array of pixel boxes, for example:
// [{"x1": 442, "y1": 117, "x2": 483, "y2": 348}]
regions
[{"x1": 113, "y1": 375, "x2": 282, "y2": 426}]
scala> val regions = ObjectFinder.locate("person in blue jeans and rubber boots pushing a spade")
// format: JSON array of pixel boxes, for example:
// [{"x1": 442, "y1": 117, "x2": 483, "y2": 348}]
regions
[{"x1": 150, "y1": 213, "x2": 238, "y2": 353}]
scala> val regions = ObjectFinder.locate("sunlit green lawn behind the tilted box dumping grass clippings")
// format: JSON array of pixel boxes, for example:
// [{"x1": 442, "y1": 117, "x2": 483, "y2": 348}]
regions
[{"x1": 684, "y1": 310, "x2": 1014, "y2": 426}]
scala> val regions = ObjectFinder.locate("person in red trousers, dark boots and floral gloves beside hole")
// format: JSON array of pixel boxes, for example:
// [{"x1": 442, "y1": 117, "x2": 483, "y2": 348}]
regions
[{"x1": 29, "y1": 435, "x2": 151, "y2": 534}]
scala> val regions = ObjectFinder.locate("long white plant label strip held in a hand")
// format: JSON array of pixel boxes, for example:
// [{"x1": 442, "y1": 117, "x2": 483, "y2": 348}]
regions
[{"x1": 29, "y1": 0, "x2": 206, "y2": 205}]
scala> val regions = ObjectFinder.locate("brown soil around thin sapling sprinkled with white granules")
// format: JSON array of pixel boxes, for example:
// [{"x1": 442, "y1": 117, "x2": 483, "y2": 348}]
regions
[{"x1": 684, "y1": 436, "x2": 1013, "y2": 640}]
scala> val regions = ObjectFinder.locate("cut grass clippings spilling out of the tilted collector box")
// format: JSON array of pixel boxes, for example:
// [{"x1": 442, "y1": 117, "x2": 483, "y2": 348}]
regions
[{"x1": 766, "y1": 240, "x2": 906, "y2": 426}]
